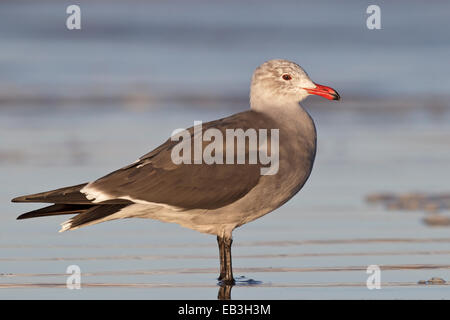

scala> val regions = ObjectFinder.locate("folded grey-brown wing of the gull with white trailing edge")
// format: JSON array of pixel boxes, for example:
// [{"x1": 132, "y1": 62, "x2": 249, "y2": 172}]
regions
[{"x1": 82, "y1": 111, "x2": 271, "y2": 209}]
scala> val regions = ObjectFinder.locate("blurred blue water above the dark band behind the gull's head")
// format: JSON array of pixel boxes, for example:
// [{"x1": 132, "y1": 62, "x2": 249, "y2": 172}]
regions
[{"x1": 0, "y1": 0, "x2": 450, "y2": 102}]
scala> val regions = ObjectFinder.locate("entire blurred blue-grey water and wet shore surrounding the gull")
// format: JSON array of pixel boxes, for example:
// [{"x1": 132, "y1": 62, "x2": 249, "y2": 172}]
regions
[{"x1": 0, "y1": 0, "x2": 450, "y2": 299}]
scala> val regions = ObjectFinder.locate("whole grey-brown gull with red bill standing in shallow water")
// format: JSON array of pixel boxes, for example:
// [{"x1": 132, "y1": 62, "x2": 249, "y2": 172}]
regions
[{"x1": 12, "y1": 60, "x2": 339, "y2": 284}]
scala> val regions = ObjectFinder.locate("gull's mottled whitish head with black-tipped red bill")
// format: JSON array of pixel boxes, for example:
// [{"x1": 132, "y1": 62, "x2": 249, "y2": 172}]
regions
[{"x1": 250, "y1": 59, "x2": 340, "y2": 109}]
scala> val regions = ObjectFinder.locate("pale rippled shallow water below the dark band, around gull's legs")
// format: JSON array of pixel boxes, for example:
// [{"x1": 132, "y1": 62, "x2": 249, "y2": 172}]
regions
[{"x1": 0, "y1": 103, "x2": 450, "y2": 299}]
